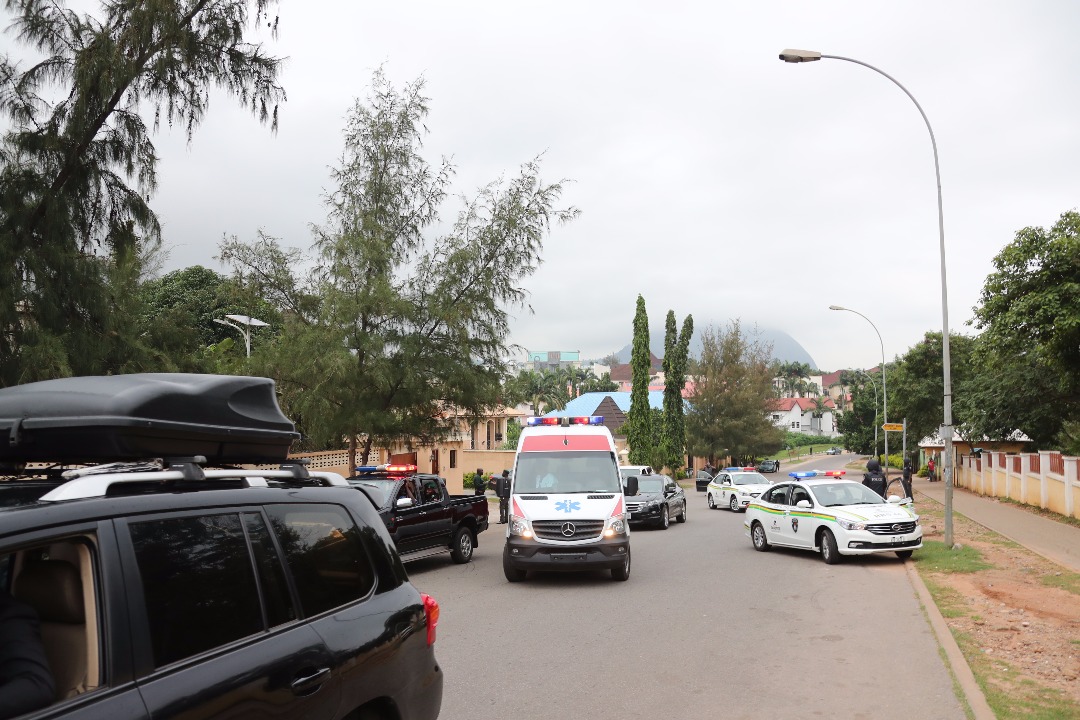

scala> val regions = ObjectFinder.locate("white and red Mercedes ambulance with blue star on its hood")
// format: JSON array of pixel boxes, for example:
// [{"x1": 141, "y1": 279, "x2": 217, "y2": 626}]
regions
[{"x1": 502, "y1": 416, "x2": 637, "y2": 582}]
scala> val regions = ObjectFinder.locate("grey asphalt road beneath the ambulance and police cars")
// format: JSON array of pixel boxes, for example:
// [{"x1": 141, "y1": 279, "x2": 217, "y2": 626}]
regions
[{"x1": 408, "y1": 456, "x2": 964, "y2": 720}]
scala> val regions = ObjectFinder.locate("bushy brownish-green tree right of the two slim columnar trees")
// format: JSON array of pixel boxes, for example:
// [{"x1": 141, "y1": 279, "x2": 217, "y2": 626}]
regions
[{"x1": 686, "y1": 321, "x2": 783, "y2": 461}]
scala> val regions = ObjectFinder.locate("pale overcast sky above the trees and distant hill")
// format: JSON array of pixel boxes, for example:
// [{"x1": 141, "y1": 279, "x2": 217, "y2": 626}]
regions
[{"x1": 42, "y1": 0, "x2": 1080, "y2": 370}]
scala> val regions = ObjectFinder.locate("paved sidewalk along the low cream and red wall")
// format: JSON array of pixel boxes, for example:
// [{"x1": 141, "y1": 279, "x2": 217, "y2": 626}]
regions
[{"x1": 912, "y1": 477, "x2": 1080, "y2": 572}]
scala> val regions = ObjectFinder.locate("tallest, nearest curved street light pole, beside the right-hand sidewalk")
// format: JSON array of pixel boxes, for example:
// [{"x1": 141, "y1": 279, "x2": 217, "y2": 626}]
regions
[{"x1": 780, "y1": 50, "x2": 953, "y2": 547}]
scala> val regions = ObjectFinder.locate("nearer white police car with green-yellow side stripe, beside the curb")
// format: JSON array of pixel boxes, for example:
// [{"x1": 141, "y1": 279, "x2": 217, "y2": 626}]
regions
[{"x1": 743, "y1": 477, "x2": 922, "y2": 565}]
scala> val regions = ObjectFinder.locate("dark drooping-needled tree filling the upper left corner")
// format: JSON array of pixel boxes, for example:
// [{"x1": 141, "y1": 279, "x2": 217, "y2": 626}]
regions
[{"x1": 0, "y1": 0, "x2": 285, "y2": 384}]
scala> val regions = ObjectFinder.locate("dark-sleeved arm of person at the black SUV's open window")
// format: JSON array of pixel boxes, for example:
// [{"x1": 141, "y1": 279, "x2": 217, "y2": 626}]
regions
[{"x1": 0, "y1": 588, "x2": 54, "y2": 720}]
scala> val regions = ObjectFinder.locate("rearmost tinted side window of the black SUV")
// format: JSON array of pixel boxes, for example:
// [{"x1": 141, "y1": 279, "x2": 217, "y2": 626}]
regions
[{"x1": 267, "y1": 505, "x2": 375, "y2": 616}]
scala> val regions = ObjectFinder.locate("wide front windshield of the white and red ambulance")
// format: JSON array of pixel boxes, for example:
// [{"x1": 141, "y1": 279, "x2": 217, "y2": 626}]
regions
[{"x1": 514, "y1": 450, "x2": 622, "y2": 494}]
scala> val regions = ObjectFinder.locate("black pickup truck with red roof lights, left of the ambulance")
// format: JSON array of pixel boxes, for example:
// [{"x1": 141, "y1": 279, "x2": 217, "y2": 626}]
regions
[{"x1": 348, "y1": 465, "x2": 488, "y2": 562}]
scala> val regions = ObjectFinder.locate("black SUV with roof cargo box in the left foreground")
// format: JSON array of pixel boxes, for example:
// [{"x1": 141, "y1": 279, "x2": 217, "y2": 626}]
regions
[{"x1": 0, "y1": 375, "x2": 443, "y2": 720}]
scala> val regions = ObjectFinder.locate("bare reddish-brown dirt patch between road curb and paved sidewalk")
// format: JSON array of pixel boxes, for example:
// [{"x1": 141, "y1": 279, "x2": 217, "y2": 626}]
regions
[{"x1": 917, "y1": 499, "x2": 1080, "y2": 711}]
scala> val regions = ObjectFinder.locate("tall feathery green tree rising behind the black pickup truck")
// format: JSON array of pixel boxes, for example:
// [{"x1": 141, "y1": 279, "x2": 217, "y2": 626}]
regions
[{"x1": 214, "y1": 70, "x2": 577, "y2": 452}]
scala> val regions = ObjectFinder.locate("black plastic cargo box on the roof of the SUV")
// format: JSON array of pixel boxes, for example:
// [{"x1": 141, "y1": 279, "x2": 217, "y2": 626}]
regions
[{"x1": 0, "y1": 372, "x2": 299, "y2": 464}]
